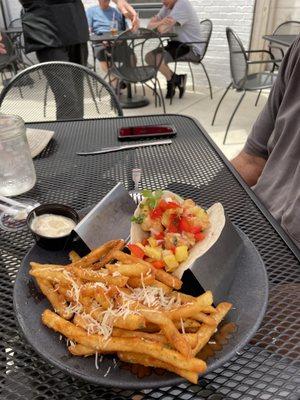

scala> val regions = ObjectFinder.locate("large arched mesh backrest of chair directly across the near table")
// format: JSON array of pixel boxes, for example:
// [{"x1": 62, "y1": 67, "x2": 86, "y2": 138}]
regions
[{"x1": 0, "y1": 61, "x2": 123, "y2": 122}]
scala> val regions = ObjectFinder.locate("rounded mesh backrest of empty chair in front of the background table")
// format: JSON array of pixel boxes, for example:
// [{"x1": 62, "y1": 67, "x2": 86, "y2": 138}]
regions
[{"x1": 111, "y1": 28, "x2": 163, "y2": 83}]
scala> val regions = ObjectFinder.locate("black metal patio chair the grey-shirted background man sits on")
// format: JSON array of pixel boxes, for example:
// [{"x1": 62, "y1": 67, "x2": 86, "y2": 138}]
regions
[{"x1": 171, "y1": 19, "x2": 213, "y2": 100}]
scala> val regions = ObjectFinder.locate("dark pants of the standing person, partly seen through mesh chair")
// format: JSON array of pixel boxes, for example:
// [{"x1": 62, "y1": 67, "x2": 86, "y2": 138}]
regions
[{"x1": 36, "y1": 43, "x2": 88, "y2": 120}]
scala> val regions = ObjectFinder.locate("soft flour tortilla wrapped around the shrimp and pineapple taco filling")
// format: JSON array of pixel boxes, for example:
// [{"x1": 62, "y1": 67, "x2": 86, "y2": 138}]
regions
[{"x1": 130, "y1": 191, "x2": 225, "y2": 278}]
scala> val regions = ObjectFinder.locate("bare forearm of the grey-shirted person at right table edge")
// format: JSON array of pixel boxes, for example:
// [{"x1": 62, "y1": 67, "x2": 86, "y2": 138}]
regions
[{"x1": 231, "y1": 150, "x2": 266, "y2": 186}]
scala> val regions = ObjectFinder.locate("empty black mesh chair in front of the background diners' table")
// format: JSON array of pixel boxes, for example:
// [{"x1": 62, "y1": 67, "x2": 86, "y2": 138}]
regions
[{"x1": 110, "y1": 28, "x2": 166, "y2": 113}]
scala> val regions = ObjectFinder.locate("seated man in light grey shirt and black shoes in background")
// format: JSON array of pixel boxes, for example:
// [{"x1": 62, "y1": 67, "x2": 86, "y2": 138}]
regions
[{"x1": 146, "y1": 0, "x2": 203, "y2": 99}]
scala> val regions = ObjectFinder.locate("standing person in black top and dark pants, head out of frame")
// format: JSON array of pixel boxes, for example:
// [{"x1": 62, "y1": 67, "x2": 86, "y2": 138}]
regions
[{"x1": 20, "y1": 0, "x2": 89, "y2": 120}]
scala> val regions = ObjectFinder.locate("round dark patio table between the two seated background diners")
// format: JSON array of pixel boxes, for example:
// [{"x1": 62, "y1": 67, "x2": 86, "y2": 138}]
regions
[{"x1": 90, "y1": 31, "x2": 177, "y2": 108}]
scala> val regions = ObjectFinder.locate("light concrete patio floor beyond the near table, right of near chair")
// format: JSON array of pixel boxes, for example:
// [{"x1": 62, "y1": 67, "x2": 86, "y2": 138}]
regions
[{"x1": 124, "y1": 82, "x2": 269, "y2": 159}]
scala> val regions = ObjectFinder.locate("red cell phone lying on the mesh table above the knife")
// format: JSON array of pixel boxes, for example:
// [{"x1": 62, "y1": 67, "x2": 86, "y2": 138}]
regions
[{"x1": 118, "y1": 125, "x2": 177, "y2": 140}]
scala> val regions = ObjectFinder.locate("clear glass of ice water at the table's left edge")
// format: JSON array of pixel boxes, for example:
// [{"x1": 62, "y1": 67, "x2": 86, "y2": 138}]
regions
[{"x1": 0, "y1": 114, "x2": 36, "y2": 196}]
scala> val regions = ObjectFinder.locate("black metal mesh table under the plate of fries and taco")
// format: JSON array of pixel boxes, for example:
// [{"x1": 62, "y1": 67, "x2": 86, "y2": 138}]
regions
[{"x1": 0, "y1": 115, "x2": 300, "y2": 400}]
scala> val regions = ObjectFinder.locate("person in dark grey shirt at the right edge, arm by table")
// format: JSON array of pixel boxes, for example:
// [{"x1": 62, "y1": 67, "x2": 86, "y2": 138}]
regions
[{"x1": 231, "y1": 36, "x2": 300, "y2": 248}]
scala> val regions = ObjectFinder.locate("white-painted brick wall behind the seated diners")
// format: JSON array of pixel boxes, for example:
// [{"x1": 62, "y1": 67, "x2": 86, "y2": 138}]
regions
[{"x1": 7, "y1": 0, "x2": 255, "y2": 87}]
